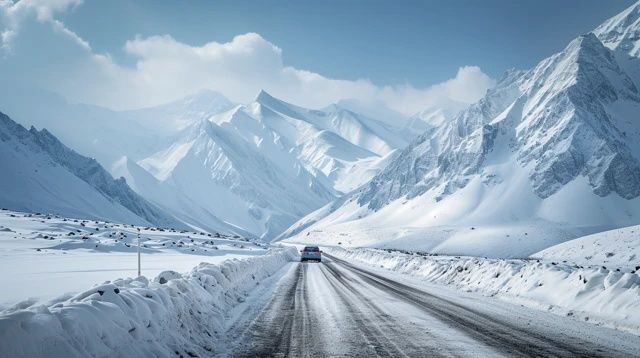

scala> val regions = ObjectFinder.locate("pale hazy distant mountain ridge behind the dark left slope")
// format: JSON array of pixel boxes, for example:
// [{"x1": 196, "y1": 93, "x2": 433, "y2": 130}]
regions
[{"x1": 0, "y1": 85, "x2": 234, "y2": 170}]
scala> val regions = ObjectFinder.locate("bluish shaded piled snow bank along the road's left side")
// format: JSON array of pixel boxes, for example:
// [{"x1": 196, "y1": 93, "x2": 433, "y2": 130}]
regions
[{"x1": 0, "y1": 248, "x2": 296, "y2": 357}]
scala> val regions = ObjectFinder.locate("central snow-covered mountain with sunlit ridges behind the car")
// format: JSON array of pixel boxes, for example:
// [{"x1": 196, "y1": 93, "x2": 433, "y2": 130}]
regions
[{"x1": 118, "y1": 91, "x2": 411, "y2": 239}]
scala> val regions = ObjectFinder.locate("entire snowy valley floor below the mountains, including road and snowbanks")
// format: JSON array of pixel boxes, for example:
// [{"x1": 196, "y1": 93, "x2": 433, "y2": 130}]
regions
[{"x1": 0, "y1": 211, "x2": 640, "y2": 357}]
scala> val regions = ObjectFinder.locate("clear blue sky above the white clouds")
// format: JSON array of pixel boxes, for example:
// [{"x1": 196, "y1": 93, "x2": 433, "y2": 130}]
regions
[{"x1": 64, "y1": 0, "x2": 633, "y2": 86}]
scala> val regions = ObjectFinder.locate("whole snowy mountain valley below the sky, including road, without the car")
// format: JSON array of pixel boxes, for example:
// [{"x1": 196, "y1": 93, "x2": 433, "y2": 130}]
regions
[{"x1": 0, "y1": 0, "x2": 640, "y2": 357}]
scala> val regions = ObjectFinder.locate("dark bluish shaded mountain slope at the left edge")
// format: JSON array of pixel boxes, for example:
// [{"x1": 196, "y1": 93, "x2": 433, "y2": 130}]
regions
[{"x1": 0, "y1": 113, "x2": 185, "y2": 227}]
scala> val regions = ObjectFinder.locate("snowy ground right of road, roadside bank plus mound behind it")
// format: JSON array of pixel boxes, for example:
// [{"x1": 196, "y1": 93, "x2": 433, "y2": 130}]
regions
[{"x1": 323, "y1": 239, "x2": 640, "y2": 334}]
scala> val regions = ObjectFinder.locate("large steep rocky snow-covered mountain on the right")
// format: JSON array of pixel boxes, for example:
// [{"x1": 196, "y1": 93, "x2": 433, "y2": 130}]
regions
[{"x1": 283, "y1": 3, "x2": 640, "y2": 256}]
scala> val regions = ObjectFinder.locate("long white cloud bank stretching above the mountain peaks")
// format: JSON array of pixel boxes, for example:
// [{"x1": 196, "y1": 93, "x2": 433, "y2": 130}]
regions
[{"x1": 0, "y1": 0, "x2": 493, "y2": 114}]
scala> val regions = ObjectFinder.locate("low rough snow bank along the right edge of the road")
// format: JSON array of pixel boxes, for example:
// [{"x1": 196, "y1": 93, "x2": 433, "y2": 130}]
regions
[{"x1": 323, "y1": 247, "x2": 640, "y2": 334}]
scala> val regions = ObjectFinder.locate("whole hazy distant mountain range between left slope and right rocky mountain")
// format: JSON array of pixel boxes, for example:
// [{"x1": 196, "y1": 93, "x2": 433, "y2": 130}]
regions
[{"x1": 0, "y1": 81, "x2": 426, "y2": 238}]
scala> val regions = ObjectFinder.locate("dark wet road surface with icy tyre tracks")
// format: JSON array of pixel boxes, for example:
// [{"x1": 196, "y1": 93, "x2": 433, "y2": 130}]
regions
[{"x1": 223, "y1": 253, "x2": 640, "y2": 357}]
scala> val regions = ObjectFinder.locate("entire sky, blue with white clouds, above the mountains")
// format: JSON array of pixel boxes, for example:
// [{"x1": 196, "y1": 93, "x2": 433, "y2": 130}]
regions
[{"x1": 0, "y1": 0, "x2": 632, "y2": 115}]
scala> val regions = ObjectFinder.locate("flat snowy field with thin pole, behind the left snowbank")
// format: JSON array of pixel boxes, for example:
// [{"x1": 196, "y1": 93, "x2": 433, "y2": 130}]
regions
[{"x1": 0, "y1": 210, "x2": 267, "y2": 310}]
